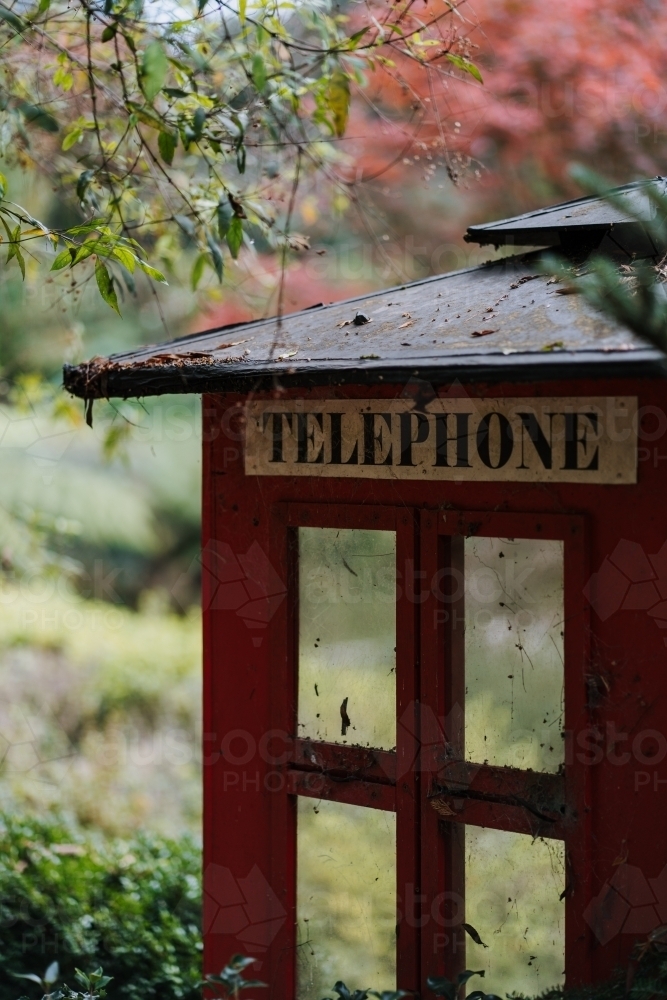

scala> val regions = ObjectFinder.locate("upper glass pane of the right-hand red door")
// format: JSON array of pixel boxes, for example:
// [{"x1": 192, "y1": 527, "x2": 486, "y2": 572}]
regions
[{"x1": 465, "y1": 538, "x2": 564, "y2": 771}]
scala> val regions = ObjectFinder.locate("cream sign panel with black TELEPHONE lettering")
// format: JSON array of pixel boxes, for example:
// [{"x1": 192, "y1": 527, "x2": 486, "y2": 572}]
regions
[{"x1": 245, "y1": 396, "x2": 637, "y2": 484}]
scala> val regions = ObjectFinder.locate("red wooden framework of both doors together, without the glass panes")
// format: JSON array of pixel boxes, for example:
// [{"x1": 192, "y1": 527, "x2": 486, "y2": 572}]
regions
[{"x1": 262, "y1": 503, "x2": 591, "y2": 1000}]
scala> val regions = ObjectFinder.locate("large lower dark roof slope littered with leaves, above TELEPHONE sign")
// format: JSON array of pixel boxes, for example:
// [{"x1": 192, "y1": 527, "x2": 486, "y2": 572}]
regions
[{"x1": 64, "y1": 253, "x2": 662, "y2": 398}]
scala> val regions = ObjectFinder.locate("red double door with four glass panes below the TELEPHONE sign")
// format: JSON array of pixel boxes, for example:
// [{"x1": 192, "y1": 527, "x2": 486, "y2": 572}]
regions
[{"x1": 258, "y1": 504, "x2": 589, "y2": 1000}]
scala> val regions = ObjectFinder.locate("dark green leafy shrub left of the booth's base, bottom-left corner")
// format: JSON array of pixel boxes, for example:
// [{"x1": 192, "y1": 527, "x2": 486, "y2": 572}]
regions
[{"x1": 0, "y1": 815, "x2": 202, "y2": 1000}]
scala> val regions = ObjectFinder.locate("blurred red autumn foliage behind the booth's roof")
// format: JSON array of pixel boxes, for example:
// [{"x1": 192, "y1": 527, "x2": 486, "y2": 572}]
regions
[{"x1": 204, "y1": 0, "x2": 667, "y2": 322}]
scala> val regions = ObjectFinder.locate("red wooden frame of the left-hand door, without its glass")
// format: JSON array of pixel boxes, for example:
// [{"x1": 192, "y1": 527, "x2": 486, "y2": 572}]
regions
[{"x1": 270, "y1": 503, "x2": 419, "y2": 1000}]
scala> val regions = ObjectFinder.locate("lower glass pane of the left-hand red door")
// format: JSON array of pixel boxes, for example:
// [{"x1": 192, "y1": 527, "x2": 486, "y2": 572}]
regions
[{"x1": 296, "y1": 797, "x2": 396, "y2": 1000}]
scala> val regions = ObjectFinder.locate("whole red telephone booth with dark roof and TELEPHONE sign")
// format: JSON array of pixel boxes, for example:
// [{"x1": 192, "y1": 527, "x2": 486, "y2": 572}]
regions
[{"x1": 65, "y1": 185, "x2": 667, "y2": 1000}]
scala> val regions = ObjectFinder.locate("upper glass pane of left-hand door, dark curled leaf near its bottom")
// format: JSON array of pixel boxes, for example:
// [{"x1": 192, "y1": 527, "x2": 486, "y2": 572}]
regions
[{"x1": 299, "y1": 528, "x2": 396, "y2": 750}]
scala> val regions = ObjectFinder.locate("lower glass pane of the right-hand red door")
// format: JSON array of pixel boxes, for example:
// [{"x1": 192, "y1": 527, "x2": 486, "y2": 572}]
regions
[{"x1": 468, "y1": 826, "x2": 565, "y2": 997}]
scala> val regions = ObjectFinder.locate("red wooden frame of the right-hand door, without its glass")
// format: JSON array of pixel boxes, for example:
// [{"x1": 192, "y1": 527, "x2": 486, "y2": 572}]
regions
[{"x1": 420, "y1": 510, "x2": 592, "y2": 986}]
